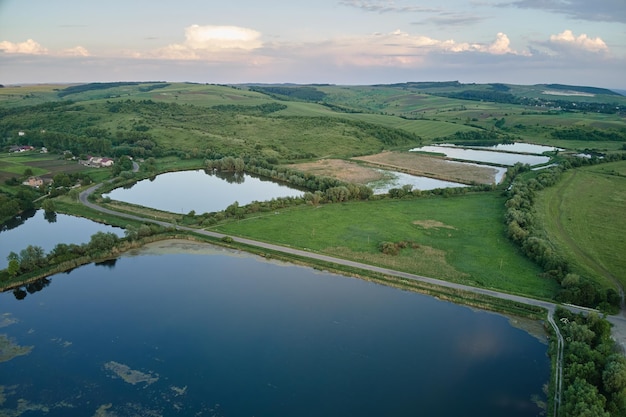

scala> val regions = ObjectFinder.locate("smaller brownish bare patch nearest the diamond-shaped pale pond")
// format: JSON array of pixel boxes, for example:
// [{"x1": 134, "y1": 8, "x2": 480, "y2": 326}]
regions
[{"x1": 289, "y1": 159, "x2": 384, "y2": 184}]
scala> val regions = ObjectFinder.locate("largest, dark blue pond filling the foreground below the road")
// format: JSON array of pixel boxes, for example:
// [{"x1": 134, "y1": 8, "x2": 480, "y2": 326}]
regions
[{"x1": 0, "y1": 244, "x2": 550, "y2": 417}]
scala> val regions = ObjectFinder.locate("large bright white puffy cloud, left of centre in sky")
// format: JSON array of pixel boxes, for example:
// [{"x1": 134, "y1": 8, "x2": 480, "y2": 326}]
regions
[{"x1": 149, "y1": 25, "x2": 263, "y2": 60}]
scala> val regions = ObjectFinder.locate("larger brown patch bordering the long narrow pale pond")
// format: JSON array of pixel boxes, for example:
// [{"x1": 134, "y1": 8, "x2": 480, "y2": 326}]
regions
[{"x1": 353, "y1": 152, "x2": 497, "y2": 184}]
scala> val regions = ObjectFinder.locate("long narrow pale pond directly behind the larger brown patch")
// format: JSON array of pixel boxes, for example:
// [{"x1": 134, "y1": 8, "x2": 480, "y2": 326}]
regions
[{"x1": 411, "y1": 145, "x2": 550, "y2": 166}]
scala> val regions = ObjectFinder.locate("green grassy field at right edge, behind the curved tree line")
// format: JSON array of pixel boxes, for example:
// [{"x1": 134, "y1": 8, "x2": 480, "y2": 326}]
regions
[{"x1": 537, "y1": 161, "x2": 626, "y2": 286}]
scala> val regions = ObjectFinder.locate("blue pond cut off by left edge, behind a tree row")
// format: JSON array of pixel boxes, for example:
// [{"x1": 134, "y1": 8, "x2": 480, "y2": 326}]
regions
[{"x1": 0, "y1": 210, "x2": 124, "y2": 269}]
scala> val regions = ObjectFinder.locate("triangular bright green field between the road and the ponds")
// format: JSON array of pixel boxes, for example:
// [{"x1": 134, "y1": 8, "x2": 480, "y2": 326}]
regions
[{"x1": 216, "y1": 193, "x2": 556, "y2": 298}]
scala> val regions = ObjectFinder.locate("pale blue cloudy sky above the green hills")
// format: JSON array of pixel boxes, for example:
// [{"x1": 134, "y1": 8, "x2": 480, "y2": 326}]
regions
[{"x1": 0, "y1": 0, "x2": 626, "y2": 89}]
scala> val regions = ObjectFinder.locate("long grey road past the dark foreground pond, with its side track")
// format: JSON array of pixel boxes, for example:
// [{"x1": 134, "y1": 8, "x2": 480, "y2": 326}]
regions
[{"x1": 79, "y1": 184, "x2": 626, "y2": 416}]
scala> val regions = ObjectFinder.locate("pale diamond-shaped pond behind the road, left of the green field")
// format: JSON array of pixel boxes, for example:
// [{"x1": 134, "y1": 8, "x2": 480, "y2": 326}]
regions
[{"x1": 103, "y1": 170, "x2": 304, "y2": 214}]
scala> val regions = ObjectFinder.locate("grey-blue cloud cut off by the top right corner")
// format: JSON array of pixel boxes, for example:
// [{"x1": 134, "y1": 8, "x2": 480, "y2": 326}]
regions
[{"x1": 498, "y1": 0, "x2": 626, "y2": 23}]
